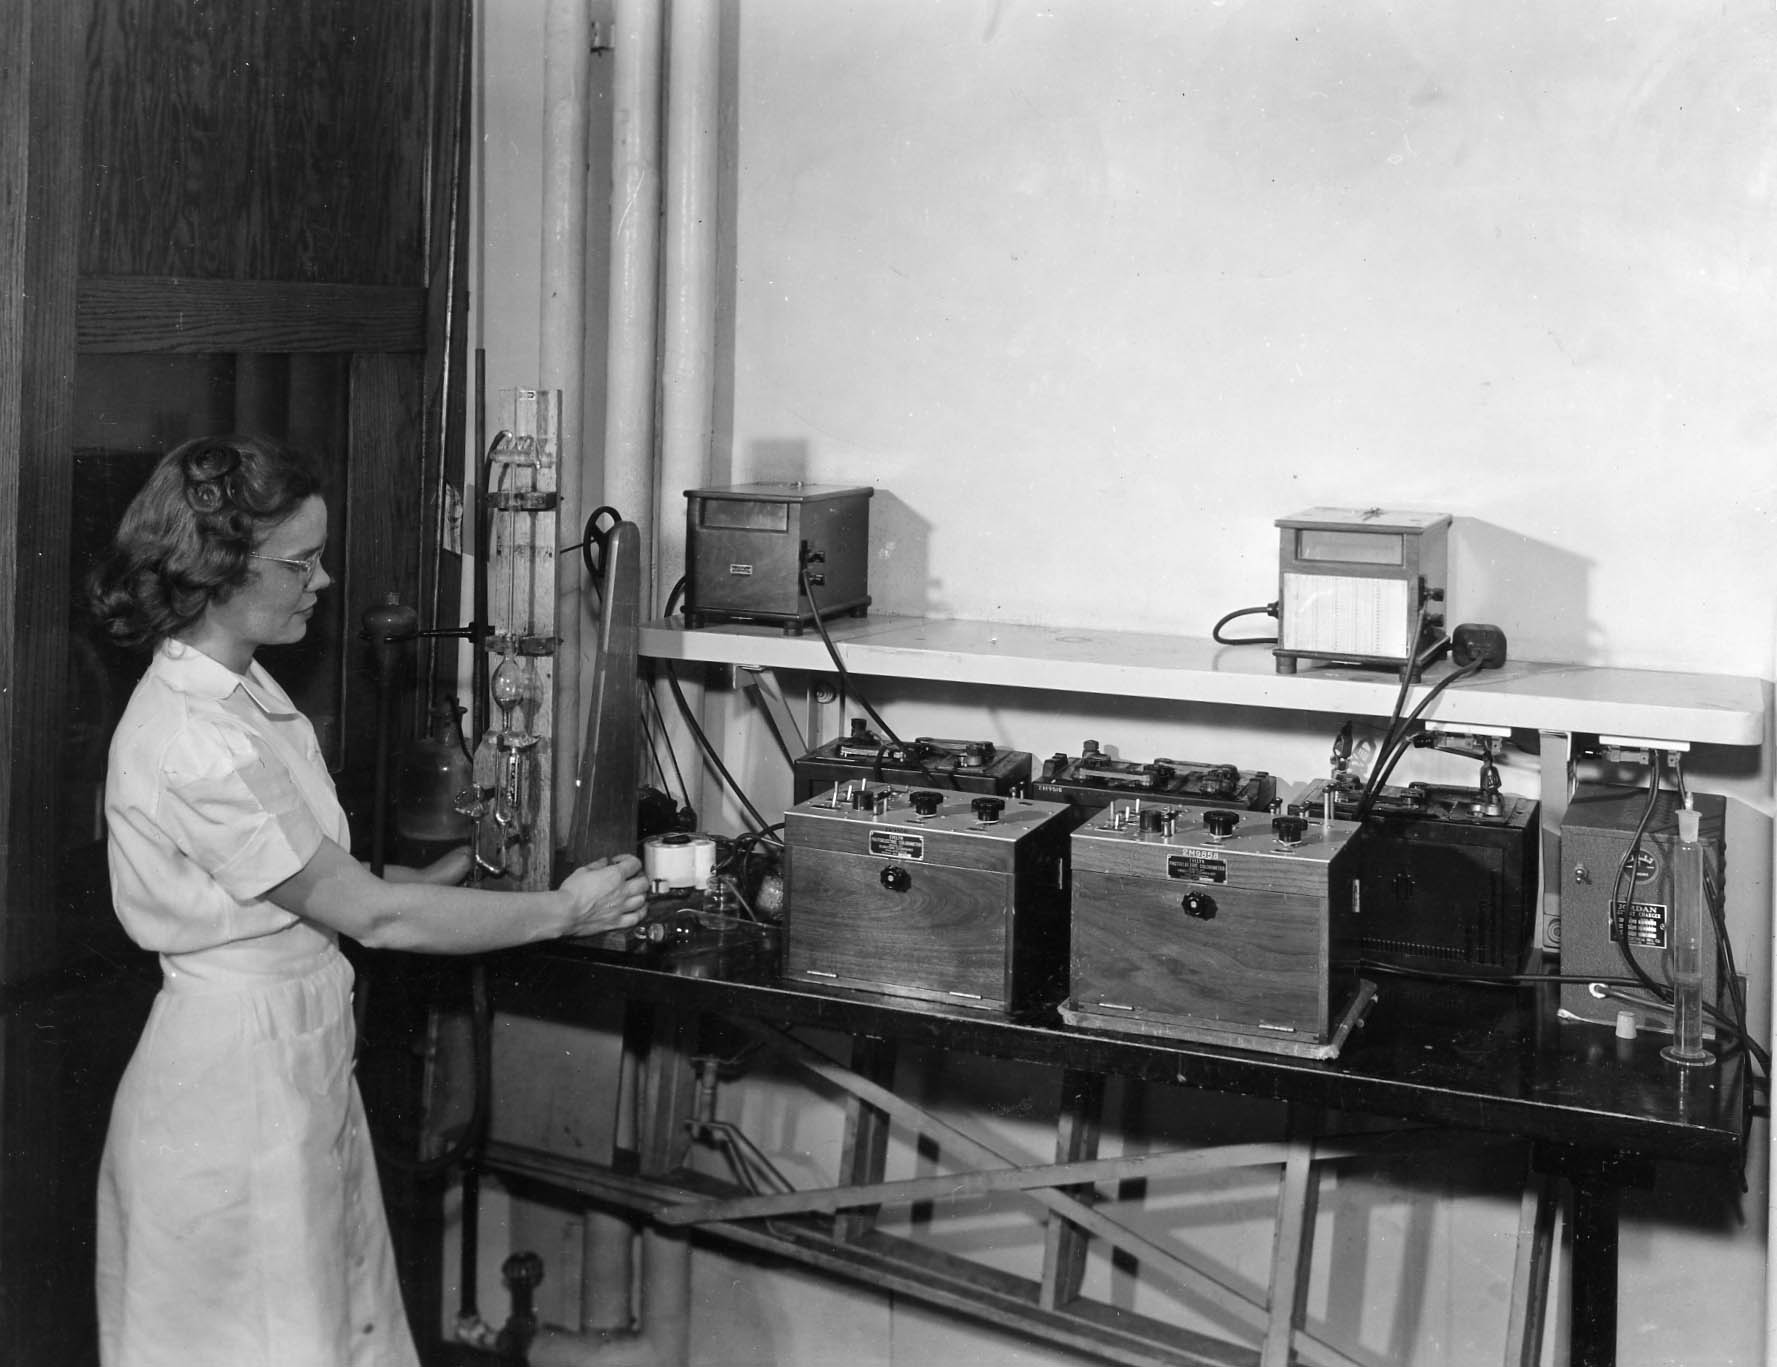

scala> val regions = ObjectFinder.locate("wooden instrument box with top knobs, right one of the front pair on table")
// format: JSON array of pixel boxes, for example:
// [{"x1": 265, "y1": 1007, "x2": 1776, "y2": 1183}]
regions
[{"x1": 1061, "y1": 802, "x2": 1375, "y2": 1058}]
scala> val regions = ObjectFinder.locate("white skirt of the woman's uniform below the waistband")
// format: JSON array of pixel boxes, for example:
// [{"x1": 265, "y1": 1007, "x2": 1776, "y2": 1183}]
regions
[{"x1": 98, "y1": 924, "x2": 418, "y2": 1367}]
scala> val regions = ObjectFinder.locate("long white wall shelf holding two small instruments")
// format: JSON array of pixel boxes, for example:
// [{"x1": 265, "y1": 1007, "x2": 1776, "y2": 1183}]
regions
[{"x1": 640, "y1": 615, "x2": 1768, "y2": 745}]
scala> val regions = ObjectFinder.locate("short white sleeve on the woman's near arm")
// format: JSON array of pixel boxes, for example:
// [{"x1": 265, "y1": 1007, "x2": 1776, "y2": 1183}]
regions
[{"x1": 156, "y1": 725, "x2": 323, "y2": 901}]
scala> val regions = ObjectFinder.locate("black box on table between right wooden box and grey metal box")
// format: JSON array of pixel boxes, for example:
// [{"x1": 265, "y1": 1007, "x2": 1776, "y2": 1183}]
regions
[{"x1": 1288, "y1": 764, "x2": 1542, "y2": 978}]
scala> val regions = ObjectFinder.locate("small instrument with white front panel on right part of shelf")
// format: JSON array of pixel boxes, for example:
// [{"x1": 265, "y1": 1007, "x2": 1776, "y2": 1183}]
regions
[{"x1": 1272, "y1": 508, "x2": 1450, "y2": 674}]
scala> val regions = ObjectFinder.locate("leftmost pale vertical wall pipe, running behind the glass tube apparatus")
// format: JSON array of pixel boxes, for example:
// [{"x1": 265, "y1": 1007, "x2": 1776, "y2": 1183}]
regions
[{"x1": 537, "y1": 0, "x2": 592, "y2": 814}]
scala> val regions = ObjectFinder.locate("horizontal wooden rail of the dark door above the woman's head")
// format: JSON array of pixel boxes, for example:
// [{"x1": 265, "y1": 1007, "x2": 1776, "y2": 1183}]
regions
[{"x1": 76, "y1": 276, "x2": 426, "y2": 352}]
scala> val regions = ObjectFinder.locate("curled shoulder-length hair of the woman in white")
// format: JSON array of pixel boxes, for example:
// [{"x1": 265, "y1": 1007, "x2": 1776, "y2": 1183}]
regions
[{"x1": 87, "y1": 436, "x2": 320, "y2": 645}]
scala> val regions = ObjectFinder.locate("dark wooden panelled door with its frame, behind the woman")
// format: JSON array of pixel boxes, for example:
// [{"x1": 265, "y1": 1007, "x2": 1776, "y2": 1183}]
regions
[{"x1": 0, "y1": 0, "x2": 471, "y2": 1367}]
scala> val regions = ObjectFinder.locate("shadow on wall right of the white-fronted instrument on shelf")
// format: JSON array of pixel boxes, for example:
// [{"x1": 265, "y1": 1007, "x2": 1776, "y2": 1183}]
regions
[{"x1": 1448, "y1": 517, "x2": 1601, "y2": 665}]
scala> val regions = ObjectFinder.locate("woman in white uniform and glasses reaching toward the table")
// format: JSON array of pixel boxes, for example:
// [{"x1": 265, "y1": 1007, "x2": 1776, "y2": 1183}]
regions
[{"x1": 91, "y1": 437, "x2": 647, "y2": 1367}]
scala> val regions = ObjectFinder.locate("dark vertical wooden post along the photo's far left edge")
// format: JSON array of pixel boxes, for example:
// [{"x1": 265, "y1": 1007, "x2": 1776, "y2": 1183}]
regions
[{"x1": 0, "y1": 15, "x2": 93, "y2": 1363}]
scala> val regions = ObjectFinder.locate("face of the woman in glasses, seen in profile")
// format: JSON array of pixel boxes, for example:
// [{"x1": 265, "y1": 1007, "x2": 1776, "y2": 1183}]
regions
[{"x1": 187, "y1": 494, "x2": 332, "y2": 674}]
